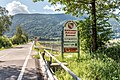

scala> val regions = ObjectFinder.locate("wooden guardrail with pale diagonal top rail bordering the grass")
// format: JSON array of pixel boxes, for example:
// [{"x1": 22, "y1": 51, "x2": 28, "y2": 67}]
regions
[{"x1": 41, "y1": 49, "x2": 81, "y2": 80}]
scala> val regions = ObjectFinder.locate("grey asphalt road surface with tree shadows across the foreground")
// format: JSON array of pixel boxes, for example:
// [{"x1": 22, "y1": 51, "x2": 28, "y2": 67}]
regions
[{"x1": 0, "y1": 43, "x2": 38, "y2": 80}]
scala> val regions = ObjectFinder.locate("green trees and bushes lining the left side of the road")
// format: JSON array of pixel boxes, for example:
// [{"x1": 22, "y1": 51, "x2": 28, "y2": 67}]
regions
[{"x1": 0, "y1": 6, "x2": 28, "y2": 50}]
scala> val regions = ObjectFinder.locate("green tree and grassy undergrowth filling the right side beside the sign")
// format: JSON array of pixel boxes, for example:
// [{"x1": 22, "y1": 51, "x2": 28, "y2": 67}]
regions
[{"x1": 33, "y1": 0, "x2": 120, "y2": 80}]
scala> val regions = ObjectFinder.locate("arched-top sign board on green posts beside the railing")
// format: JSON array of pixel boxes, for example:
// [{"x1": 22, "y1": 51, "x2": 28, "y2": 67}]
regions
[{"x1": 62, "y1": 21, "x2": 80, "y2": 58}]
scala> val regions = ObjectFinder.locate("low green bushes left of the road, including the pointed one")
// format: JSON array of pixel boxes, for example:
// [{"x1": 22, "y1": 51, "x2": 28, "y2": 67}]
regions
[{"x1": 0, "y1": 27, "x2": 28, "y2": 50}]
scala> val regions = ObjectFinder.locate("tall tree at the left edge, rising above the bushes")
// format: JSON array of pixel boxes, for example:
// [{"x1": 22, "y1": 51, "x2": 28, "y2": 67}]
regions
[{"x1": 0, "y1": 6, "x2": 12, "y2": 36}]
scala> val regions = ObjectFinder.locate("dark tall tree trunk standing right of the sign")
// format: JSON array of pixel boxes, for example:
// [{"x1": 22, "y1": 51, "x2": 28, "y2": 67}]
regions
[{"x1": 91, "y1": 0, "x2": 98, "y2": 52}]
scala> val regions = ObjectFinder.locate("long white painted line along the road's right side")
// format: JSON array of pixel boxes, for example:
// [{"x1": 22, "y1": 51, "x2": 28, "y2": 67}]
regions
[{"x1": 17, "y1": 42, "x2": 34, "y2": 80}]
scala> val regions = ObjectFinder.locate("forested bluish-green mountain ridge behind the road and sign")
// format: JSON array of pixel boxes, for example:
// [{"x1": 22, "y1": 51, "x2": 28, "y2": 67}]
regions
[{"x1": 7, "y1": 14, "x2": 83, "y2": 38}]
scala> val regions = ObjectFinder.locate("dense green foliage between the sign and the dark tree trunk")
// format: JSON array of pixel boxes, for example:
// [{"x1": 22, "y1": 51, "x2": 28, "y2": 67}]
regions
[{"x1": 77, "y1": 19, "x2": 92, "y2": 51}]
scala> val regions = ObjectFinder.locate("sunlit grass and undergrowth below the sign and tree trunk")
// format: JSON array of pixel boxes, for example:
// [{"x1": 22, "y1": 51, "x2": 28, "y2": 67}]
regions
[{"x1": 55, "y1": 53, "x2": 120, "y2": 80}]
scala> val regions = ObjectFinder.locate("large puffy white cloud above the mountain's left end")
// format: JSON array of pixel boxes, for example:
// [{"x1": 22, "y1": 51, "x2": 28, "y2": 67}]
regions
[{"x1": 6, "y1": 1, "x2": 29, "y2": 15}]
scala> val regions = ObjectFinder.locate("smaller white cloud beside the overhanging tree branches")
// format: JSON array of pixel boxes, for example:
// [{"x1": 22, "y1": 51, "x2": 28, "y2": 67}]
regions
[{"x1": 43, "y1": 4, "x2": 64, "y2": 14}]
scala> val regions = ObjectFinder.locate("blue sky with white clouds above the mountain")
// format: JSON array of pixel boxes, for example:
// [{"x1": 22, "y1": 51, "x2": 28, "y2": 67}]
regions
[{"x1": 0, "y1": 0, "x2": 64, "y2": 15}]
